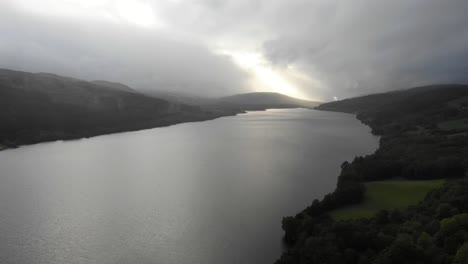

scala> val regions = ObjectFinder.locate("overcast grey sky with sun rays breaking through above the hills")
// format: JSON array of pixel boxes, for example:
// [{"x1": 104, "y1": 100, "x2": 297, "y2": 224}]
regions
[{"x1": 0, "y1": 0, "x2": 468, "y2": 101}]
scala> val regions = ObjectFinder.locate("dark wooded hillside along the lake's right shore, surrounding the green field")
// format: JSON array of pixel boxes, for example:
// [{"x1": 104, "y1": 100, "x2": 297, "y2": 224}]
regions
[{"x1": 277, "y1": 85, "x2": 468, "y2": 264}]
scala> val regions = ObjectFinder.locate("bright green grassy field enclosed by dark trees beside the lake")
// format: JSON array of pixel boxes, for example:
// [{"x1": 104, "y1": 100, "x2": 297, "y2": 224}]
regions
[{"x1": 330, "y1": 180, "x2": 444, "y2": 220}]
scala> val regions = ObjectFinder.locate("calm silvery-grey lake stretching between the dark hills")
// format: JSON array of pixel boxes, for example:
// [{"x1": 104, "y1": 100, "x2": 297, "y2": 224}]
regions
[{"x1": 0, "y1": 109, "x2": 378, "y2": 264}]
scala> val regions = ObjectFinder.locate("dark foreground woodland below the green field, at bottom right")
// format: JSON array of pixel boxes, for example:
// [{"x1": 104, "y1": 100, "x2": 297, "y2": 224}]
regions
[{"x1": 277, "y1": 179, "x2": 468, "y2": 264}]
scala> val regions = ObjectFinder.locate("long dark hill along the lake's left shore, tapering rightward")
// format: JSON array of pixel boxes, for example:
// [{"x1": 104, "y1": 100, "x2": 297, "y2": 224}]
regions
[{"x1": 0, "y1": 69, "x2": 229, "y2": 148}]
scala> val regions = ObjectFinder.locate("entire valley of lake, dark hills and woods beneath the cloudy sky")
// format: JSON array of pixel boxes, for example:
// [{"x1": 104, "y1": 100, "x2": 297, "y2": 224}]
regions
[{"x1": 0, "y1": 70, "x2": 468, "y2": 264}]
